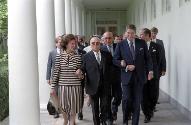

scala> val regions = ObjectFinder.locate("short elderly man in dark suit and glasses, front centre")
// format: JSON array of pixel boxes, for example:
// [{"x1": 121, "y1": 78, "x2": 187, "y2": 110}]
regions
[{"x1": 82, "y1": 37, "x2": 112, "y2": 125}]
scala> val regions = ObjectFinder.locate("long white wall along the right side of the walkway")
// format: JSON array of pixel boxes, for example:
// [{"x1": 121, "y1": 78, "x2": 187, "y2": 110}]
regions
[{"x1": 128, "y1": 0, "x2": 191, "y2": 111}]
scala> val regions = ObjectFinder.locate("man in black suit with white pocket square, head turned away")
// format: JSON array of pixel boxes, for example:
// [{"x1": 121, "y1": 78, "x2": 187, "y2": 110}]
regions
[{"x1": 140, "y1": 28, "x2": 162, "y2": 123}]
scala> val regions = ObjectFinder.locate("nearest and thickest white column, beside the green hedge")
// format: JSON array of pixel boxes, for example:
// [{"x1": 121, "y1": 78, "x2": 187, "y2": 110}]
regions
[{"x1": 8, "y1": 0, "x2": 40, "y2": 125}]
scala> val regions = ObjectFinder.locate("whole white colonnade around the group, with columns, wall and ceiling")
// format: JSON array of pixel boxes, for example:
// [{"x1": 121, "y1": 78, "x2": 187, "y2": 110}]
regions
[{"x1": 8, "y1": 0, "x2": 191, "y2": 125}]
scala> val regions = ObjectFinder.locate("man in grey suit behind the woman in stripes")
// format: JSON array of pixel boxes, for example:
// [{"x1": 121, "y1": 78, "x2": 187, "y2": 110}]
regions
[{"x1": 46, "y1": 36, "x2": 62, "y2": 118}]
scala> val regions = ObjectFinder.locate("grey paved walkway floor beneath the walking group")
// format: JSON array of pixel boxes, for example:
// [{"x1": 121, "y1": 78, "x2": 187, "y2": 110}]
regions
[{"x1": 40, "y1": 94, "x2": 191, "y2": 125}]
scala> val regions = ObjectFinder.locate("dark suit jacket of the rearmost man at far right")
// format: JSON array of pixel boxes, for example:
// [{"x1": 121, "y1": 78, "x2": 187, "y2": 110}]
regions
[{"x1": 156, "y1": 39, "x2": 166, "y2": 73}]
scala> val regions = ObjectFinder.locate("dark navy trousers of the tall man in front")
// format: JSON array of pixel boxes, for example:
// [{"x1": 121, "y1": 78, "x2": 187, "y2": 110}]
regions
[{"x1": 122, "y1": 74, "x2": 143, "y2": 125}]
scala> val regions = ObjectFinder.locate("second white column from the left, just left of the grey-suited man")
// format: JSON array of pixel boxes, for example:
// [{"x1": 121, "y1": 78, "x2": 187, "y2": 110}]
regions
[{"x1": 37, "y1": 0, "x2": 55, "y2": 108}]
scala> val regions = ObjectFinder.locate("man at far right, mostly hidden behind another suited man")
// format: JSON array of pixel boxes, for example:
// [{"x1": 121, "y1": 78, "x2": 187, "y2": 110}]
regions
[{"x1": 151, "y1": 27, "x2": 166, "y2": 108}]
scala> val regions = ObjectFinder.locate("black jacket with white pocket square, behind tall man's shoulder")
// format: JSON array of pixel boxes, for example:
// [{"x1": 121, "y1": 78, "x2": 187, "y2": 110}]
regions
[{"x1": 149, "y1": 42, "x2": 162, "y2": 79}]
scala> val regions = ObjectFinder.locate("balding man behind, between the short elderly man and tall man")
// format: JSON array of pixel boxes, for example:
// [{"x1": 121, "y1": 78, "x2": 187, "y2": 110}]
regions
[{"x1": 101, "y1": 32, "x2": 122, "y2": 122}]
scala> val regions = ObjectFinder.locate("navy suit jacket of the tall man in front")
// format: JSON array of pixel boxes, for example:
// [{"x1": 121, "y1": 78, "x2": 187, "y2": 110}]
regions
[{"x1": 113, "y1": 38, "x2": 153, "y2": 85}]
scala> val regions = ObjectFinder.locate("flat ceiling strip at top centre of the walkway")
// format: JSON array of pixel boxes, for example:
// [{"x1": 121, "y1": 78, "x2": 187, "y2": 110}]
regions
[{"x1": 82, "y1": 0, "x2": 131, "y2": 10}]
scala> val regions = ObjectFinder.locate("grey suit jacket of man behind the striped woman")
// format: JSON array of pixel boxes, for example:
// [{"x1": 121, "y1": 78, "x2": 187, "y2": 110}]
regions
[{"x1": 46, "y1": 49, "x2": 57, "y2": 80}]
